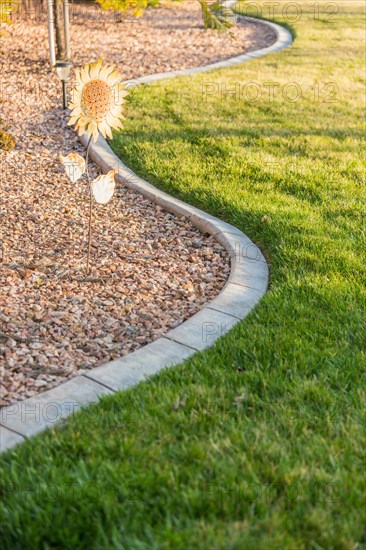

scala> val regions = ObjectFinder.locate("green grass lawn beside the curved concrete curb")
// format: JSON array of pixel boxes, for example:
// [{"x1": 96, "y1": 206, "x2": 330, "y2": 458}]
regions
[{"x1": 0, "y1": 1, "x2": 366, "y2": 550}]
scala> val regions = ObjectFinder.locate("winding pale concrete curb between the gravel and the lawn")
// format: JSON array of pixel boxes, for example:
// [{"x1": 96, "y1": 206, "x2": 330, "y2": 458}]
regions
[{"x1": 0, "y1": 10, "x2": 292, "y2": 452}]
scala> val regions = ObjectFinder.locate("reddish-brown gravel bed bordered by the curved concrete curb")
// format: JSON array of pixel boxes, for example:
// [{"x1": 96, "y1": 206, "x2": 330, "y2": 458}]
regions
[{"x1": 0, "y1": 2, "x2": 274, "y2": 405}]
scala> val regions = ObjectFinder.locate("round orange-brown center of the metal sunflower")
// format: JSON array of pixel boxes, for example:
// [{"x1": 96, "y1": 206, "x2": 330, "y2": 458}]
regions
[{"x1": 81, "y1": 79, "x2": 113, "y2": 121}]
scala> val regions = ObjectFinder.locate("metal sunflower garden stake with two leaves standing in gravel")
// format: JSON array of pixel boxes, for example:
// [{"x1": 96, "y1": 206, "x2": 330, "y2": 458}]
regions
[{"x1": 60, "y1": 60, "x2": 128, "y2": 274}]
